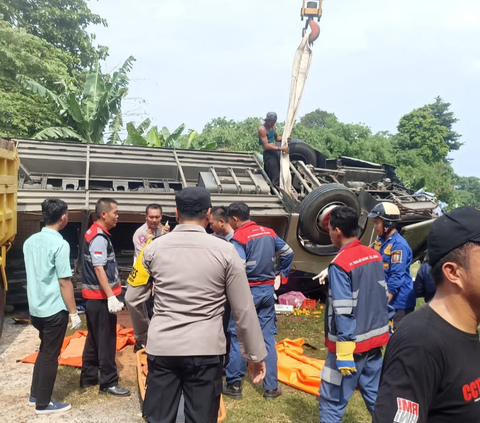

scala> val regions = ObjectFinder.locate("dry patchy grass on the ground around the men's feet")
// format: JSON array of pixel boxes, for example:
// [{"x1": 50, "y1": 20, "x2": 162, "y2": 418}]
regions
[{"x1": 49, "y1": 292, "x2": 424, "y2": 423}]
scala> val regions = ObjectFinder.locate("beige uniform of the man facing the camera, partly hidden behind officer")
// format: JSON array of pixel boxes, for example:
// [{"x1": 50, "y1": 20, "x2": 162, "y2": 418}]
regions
[{"x1": 125, "y1": 222, "x2": 165, "y2": 346}]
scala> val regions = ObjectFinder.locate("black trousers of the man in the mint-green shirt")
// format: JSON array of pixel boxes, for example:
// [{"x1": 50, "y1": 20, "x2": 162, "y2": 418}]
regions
[{"x1": 30, "y1": 311, "x2": 68, "y2": 410}]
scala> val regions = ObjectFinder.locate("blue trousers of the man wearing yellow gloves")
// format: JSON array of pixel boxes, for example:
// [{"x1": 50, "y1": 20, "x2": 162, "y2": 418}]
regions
[{"x1": 319, "y1": 348, "x2": 383, "y2": 423}]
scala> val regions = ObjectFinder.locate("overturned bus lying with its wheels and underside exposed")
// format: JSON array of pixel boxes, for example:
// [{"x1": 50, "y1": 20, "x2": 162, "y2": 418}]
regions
[{"x1": 7, "y1": 139, "x2": 437, "y2": 304}]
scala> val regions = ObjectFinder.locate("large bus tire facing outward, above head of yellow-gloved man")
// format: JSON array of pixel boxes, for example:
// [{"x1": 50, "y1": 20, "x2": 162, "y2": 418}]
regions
[{"x1": 298, "y1": 184, "x2": 360, "y2": 245}]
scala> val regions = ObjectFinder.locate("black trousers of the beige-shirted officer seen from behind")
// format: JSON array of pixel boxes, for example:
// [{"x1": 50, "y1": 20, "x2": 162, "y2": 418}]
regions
[{"x1": 143, "y1": 355, "x2": 223, "y2": 423}]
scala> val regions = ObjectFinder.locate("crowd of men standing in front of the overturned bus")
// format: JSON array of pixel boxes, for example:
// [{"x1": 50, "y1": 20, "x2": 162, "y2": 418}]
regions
[{"x1": 24, "y1": 187, "x2": 480, "y2": 423}]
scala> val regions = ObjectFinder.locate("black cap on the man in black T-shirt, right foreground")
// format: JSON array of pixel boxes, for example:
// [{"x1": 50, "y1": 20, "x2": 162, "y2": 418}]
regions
[{"x1": 427, "y1": 206, "x2": 480, "y2": 266}]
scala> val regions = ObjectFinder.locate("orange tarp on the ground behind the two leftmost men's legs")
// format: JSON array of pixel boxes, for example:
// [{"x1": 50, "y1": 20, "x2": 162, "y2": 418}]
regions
[{"x1": 20, "y1": 325, "x2": 135, "y2": 367}]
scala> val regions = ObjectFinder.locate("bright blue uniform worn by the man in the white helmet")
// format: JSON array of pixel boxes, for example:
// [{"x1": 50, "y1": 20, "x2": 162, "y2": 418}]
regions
[{"x1": 374, "y1": 231, "x2": 416, "y2": 328}]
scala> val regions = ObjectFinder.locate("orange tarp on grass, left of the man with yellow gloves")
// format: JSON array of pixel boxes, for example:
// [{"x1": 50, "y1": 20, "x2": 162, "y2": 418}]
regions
[{"x1": 275, "y1": 338, "x2": 325, "y2": 396}]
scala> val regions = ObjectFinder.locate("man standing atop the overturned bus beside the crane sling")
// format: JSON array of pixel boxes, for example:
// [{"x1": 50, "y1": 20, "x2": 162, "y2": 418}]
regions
[{"x1": 258, "y1": 112, "x2": 289, "y2": 187}]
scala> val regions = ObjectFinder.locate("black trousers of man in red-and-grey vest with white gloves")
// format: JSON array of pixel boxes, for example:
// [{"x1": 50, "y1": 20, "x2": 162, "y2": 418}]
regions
[{"x1": 80, "y1": 300, "x2": 118, "y2": 388}]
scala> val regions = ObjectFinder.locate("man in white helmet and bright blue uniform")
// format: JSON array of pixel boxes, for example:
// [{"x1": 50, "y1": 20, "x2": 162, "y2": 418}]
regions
[{"x1": 368, "y1": 202, "x2": 416, "y2": 330}]
